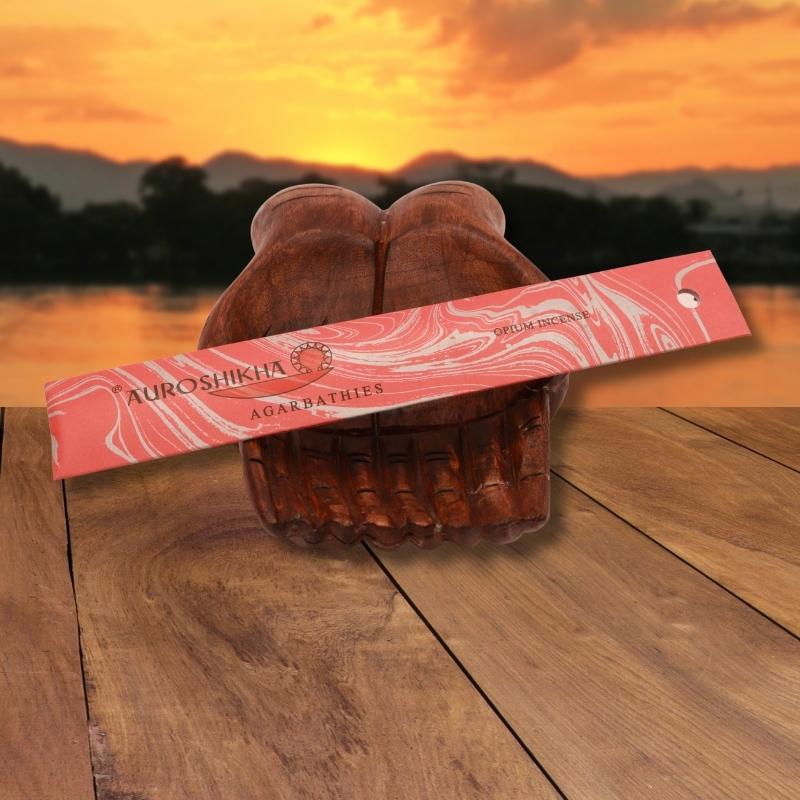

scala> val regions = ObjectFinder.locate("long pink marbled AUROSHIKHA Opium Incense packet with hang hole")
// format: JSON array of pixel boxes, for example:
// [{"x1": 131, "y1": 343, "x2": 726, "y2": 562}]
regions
[{"x1": 45, "y1": 252, "x2": 750, "y2": 478}]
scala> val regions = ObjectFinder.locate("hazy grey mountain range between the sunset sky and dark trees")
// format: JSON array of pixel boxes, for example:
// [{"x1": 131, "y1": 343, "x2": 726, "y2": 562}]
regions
[{"x1": 0, "y1": 138, "x2": 800, "y2": 217}]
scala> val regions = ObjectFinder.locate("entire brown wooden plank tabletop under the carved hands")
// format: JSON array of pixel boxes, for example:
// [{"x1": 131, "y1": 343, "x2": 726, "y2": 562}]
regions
[{"x1": 0, "y1": 408, "x2": 800, "y2": 800}]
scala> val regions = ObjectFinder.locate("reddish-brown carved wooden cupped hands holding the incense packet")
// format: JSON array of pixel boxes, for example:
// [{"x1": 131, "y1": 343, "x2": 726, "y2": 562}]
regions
[{"x1": 199, "y1": 181, "x2": 567, "y2": 547}]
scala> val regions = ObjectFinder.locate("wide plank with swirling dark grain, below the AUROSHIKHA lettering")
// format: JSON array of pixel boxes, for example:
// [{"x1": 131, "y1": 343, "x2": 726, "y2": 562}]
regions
[{"x1": 66, "y1": 448, "x2": 562, "y2": 800}]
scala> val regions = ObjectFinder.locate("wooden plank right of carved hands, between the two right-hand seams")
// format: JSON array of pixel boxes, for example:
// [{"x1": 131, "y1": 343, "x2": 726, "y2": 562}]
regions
[{"x1": 552, "y1": 408, "x2": 800, "y2": 634}]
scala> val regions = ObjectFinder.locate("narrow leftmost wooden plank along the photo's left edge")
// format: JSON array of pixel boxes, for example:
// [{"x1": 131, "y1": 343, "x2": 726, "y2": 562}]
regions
[{"x1": 0, "y1": 407, "x2": 95, "y2": 800}]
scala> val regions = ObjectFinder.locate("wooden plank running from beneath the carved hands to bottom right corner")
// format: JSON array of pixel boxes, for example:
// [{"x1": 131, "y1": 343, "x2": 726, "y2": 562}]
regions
[{"x1": 368, "y1": 477, "x2": 800, "y2": 800}]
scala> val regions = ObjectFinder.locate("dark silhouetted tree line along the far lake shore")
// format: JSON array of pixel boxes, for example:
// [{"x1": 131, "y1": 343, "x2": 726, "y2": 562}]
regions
[{"x1": 0, "y1": 158, "x2": 800, "y2": 287}]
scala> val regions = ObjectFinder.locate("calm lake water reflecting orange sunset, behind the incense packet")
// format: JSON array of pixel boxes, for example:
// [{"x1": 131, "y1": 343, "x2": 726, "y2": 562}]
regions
[{"x1": 0, "y1": 286, "x2": 800, "y2": 406}]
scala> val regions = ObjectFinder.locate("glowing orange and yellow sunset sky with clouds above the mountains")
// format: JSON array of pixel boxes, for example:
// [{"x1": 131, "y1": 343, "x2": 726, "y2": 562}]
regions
[{"x1": 0, "y1": 0, "x2": 800, "y2": 174}]
